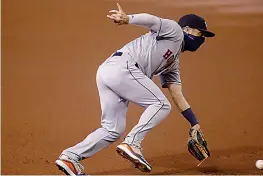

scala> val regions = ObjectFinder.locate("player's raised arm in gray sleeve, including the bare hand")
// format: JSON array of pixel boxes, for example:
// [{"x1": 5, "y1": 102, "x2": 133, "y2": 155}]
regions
[{"x1": 107, "y1": 3, "x2": 161, "y2": 31}]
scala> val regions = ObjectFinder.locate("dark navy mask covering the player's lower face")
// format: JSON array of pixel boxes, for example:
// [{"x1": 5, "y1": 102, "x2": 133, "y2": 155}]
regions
[{"x1": 182, "y1": 32, "x2": 205, "y2": 52}]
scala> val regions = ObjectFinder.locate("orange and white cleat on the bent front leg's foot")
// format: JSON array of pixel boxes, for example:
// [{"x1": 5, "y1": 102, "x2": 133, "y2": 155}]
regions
[{"x1": 116, "y1": 143, "x2": 152, "y2": 172}]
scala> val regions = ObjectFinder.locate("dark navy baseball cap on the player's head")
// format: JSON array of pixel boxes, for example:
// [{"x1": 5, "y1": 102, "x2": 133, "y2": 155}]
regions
[{"x1": 178, "y1": 14, "x2": 215, "y2": 37}]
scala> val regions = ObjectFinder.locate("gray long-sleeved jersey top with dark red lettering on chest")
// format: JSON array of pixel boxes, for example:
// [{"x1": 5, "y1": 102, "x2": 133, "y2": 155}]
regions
[{"x1": 120, "y1": 14, "x2": 184, "y2": 87}]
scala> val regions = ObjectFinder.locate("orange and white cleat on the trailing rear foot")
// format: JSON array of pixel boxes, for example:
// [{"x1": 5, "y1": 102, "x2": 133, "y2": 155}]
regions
[{"x1": 56, "y1": 155, "x2": 86, "y2": 176}]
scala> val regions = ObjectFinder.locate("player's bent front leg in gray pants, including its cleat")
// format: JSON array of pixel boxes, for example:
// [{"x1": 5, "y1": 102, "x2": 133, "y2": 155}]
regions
[{"x1": 104, "y1": 58, "x2": 171, "y2": 172}]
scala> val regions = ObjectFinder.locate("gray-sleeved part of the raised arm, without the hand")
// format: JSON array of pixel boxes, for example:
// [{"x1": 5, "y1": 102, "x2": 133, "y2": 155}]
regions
[{"x1": 128, "y1": 13, "x2": 160, "y2": 31}]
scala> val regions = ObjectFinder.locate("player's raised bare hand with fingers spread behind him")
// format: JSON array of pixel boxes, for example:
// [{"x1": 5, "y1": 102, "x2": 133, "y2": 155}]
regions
[{"x1": 107, "y1": 3, "x2": 129, "y2": 25}]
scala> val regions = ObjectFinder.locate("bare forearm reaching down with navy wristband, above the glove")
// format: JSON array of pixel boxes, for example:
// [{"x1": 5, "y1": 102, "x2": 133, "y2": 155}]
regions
[{"x1": 167, "y1": 83, "x2": 198, "y2": 126}]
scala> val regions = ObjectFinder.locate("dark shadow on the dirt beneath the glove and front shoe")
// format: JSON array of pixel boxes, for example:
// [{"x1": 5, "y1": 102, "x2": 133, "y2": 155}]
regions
[{"x1": 90, "y1": 147, "x2": 263, "y2": 175}]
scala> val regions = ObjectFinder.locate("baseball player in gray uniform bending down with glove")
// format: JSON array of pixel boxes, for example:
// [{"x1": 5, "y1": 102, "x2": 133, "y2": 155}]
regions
[{"x1": 56, "y1": 4, "x2": 215, "y2": 175}]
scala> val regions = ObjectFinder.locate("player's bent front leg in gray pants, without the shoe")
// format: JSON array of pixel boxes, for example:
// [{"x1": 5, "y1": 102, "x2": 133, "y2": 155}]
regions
[{"x1": 104, "y1": 61, "x2": 171, "y2": 148}]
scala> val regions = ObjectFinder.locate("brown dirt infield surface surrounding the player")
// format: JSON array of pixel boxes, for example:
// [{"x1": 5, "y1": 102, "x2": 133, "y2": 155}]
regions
[{"x1": 1, "y1": 0, "x2": 263, "y2": 175}]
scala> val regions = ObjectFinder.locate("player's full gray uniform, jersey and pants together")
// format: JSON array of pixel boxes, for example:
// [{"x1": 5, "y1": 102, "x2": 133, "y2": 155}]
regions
[{"x1": 62, "y1": 14, "x2": 184, "y2": 160}]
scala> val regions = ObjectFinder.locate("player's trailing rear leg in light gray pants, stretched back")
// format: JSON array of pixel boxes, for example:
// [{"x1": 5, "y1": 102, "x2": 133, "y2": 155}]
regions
[{"x1": 57, "y1": 65, "x2": 128, "y2": 173}]
